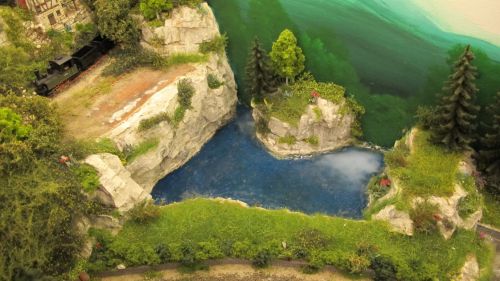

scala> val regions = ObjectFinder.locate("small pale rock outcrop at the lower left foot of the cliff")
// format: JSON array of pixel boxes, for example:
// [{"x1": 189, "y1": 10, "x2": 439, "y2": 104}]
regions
[{"x1": 85, "y1": 153, "x2": 151, "y2": 211}]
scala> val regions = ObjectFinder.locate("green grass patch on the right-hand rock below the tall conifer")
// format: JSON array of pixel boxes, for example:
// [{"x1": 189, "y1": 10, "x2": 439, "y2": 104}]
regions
[{"x1": 388, "y1": 131, "x2": 462, "y2": 198}]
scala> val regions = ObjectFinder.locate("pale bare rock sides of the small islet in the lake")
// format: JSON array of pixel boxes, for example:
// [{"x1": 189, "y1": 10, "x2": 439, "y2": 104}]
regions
[{"x1": 253, "y1": 98, "x2": 356, "y2": 157}]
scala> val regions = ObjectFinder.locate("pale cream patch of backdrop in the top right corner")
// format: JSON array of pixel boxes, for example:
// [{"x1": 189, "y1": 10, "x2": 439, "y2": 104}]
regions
[{"x1": 411, "y1": 0, "x2": 500, "y2": 46}]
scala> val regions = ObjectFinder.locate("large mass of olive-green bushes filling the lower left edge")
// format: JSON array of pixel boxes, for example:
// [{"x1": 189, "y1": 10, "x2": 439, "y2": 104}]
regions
[{"x1": 0, "y1": 93, "x2": 88, "y2": 280}]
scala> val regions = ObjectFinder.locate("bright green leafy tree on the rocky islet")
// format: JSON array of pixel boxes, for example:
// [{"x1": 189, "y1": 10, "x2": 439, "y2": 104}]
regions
[{"x1": 270, "y1": 29, "x2": 305, "y2": 85}]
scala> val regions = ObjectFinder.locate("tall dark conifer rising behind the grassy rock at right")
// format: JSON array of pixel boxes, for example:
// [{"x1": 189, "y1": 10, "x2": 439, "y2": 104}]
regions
[{"x1": 432, "y1": 46, "x2": 479, "y2": 151}]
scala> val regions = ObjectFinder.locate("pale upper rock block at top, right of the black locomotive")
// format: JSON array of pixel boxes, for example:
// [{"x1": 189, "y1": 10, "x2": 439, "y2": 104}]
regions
[{"x1": 142, "y1": 3, "x2": 219, "y2": 54}]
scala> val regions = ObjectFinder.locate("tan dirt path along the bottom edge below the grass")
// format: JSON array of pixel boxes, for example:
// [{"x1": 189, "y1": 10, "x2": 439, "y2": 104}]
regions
[{"x1": 101, "y1": 260, "x2": 369, "y2": 281}]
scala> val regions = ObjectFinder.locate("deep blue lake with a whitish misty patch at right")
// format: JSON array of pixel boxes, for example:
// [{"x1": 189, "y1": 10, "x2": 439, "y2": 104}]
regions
[{"x1": 152, "y1": 107, "x2": 383, "y2": 218}]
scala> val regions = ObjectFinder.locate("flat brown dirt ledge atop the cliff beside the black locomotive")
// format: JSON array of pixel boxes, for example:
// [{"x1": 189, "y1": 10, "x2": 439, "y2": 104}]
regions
[{"x1": 53, "y1": 58, "x2": 194, "y2": 139}]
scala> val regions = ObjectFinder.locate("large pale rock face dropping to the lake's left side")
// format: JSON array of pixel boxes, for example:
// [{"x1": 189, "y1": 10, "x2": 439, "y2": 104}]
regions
[{"x1": 110, "y1": 55, "x2": 237, "y2": 192}]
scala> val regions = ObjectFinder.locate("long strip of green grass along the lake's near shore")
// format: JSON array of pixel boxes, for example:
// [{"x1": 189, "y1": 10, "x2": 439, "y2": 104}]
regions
[{"x1": 92, "y1": 199, "x2": 491, "y2": 280}]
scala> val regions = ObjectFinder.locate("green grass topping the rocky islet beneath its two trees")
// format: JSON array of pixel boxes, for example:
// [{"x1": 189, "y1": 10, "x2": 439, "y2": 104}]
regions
[{"x1": 270, "y1": 80, "x2": 347, "y2": 126}]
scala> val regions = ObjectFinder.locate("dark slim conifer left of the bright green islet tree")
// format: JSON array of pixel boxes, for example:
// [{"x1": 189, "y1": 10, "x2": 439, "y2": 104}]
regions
[{"x1": 246, "y1": 38, "x2": 276, "y2": 102}]
